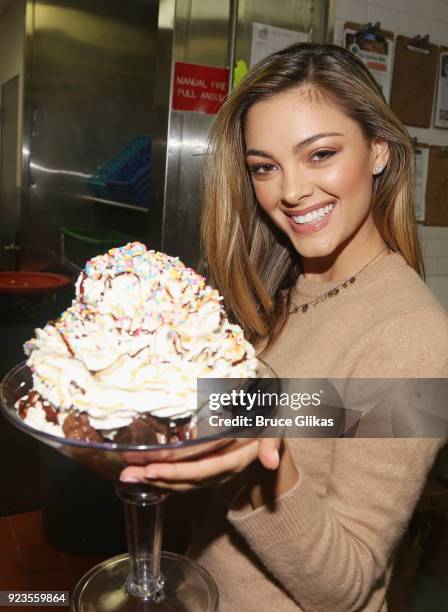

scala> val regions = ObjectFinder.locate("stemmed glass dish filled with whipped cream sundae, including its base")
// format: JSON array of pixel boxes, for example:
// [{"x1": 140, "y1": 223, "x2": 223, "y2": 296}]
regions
[{"x1": 1, "y1": 243, "x2": 275, "y2": 612}]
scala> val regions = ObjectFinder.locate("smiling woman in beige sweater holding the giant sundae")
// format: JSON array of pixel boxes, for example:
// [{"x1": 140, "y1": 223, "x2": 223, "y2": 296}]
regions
[{"x1": 123, "y1": 44, "x2": 448, "y2": 612}]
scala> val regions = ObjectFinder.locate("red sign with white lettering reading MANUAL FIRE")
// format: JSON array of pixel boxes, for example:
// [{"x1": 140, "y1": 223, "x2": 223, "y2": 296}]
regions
[{"x1": 172, "y1": 62, "x2": 229, "y2": 115}]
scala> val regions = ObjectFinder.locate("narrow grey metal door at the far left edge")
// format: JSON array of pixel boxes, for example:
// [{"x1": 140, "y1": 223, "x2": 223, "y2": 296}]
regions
[{"x1": 0, "y1": 76, "x2": 20, "y2": 269}]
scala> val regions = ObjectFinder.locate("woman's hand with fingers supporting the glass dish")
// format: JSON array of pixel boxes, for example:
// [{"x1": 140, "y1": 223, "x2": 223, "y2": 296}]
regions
[{"x1": 120, "y1": 438, "x2": 282, "y2": 491}]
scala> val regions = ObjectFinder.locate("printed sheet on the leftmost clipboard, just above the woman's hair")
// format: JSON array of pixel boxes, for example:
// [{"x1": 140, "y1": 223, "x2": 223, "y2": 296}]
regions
[{"x1": 343, "y1": 29, "x2": 395, "y2": 103}]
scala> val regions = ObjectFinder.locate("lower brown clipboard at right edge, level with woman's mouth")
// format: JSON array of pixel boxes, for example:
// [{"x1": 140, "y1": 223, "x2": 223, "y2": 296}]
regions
[{"x1": 424, "y1": 145, "x2": 448, "y2": 227}]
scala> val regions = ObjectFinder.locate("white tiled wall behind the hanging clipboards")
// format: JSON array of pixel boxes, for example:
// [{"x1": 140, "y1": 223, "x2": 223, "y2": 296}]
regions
[{"x1": 334, "y1": 0, "x2": 448, "y2": 309}]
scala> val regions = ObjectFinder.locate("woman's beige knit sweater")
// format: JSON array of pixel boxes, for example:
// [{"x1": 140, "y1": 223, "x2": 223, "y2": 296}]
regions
[{"x1": 190, "y1": 254, "x2": 448, "y2": 612}]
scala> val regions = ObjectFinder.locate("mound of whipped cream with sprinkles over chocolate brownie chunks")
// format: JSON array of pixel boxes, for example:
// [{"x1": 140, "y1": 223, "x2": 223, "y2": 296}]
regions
[{"x1": 16, "y1": 243, "x2": 257, "y2": 443}]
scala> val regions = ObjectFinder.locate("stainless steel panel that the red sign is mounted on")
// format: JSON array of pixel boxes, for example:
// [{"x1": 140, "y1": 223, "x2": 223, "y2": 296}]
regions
[{"x1": 162, "y1": 0, "x2": 230, "y2": 266}]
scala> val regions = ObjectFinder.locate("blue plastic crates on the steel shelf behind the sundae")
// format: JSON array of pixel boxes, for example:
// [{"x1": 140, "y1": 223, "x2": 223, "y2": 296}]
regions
[{"x1": 87, "y1": 135, "x2": 152, "y2": 204}]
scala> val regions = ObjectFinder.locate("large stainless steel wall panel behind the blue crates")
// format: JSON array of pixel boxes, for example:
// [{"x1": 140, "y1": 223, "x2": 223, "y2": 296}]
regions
[{"x1": 21, "y1": 0, "x2": 171, "y2": 267}]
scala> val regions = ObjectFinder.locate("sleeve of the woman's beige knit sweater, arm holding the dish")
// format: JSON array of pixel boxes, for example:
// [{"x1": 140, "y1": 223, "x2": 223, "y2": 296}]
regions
[{"x1": 228, "y1": 313, "x2": 448, "y2": 612}]
